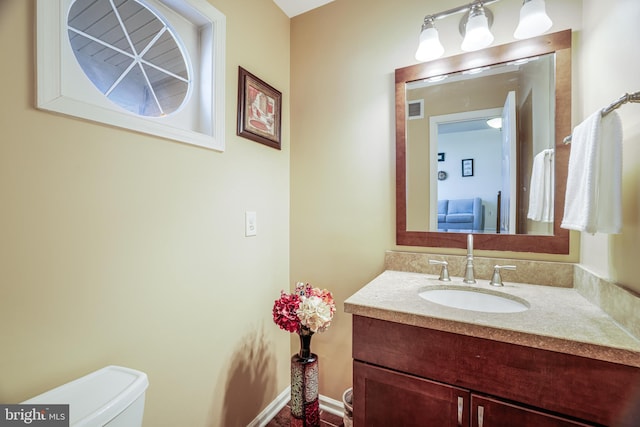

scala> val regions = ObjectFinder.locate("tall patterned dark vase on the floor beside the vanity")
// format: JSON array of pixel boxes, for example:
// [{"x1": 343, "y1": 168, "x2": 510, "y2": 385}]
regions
[{"x1": 291, "y1": 328, "x2": 320, "y2": 427}]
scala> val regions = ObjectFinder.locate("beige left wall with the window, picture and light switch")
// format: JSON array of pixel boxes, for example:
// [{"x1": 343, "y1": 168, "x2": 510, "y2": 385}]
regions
[{"x1": 0, "y1": 0, "x2": 290, "y2": 427}]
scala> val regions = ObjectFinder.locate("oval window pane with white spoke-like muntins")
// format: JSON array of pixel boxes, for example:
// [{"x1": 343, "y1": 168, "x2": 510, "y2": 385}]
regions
[{"x1": 67, "y1": 0, "x2": 191, "y2": 117}]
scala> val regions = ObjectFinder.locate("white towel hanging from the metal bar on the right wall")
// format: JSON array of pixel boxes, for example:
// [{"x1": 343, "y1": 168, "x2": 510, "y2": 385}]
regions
[{"x1": 561, "y1": 111, "x2": 622, "y2": 234}]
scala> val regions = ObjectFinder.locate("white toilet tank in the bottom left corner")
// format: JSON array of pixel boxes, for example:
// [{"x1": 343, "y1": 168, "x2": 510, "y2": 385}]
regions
[{"x1": 22, "y1": 366, "x2": 149, "y2": 427}]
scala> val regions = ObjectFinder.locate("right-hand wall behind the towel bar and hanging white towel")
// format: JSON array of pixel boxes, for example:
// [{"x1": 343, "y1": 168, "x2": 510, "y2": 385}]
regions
[{"x1": 574, "y1": 0, "x2": 640, "y2": 294}]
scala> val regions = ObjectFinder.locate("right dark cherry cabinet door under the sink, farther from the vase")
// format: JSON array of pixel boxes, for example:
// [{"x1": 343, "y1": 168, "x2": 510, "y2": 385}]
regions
[{"x1": 471, "y1": 395, "x2": 592, "y2": 427}]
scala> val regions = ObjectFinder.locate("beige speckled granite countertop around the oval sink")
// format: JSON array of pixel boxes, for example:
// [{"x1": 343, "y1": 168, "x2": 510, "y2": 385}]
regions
[{"x1": 344, "y1": 270, "x2": 640, "y2": 367}]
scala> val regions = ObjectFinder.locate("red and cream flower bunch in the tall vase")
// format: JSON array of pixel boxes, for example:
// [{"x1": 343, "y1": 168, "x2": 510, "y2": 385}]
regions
[{"x1": 273, "y1": 282, "x2": 336, "y2": 335}]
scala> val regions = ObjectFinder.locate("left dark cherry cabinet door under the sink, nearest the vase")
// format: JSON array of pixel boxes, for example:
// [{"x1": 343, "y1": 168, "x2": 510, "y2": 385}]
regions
[{"x1": 353, "y1": 361, "x2": 470, "y2": 427}]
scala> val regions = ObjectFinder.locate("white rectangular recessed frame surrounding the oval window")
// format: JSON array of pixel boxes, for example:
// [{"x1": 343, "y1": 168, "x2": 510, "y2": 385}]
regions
[{"x1": 36, "y1": 0, "x2": 226, "y2": 151}]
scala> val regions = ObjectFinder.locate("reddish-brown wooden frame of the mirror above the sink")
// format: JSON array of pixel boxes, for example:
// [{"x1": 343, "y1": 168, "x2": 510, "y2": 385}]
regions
[{"x1": 395, "y1": 30, "x2": 571, "y2": 254}]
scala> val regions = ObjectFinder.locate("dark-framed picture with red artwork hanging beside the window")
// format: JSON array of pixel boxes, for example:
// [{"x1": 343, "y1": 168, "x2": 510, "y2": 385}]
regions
[{"x1": 237, "y1": 67, "x2": 282, "y2": 150}]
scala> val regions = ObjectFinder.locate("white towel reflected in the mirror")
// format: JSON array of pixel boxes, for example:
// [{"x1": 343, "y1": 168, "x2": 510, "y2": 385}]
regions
[{"x1": 527, "y1": 148, "x2": 555, "y2": 222}]
